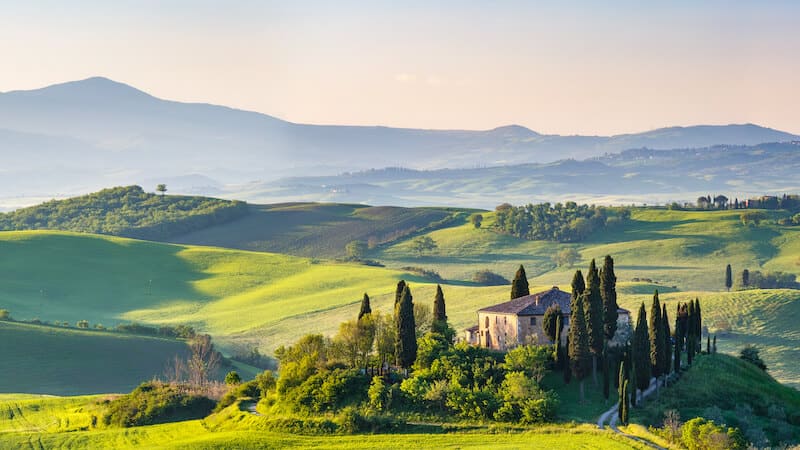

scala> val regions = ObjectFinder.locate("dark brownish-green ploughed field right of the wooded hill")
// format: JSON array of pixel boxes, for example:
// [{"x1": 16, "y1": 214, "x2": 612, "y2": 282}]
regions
[{"x1": 170, "y1": 203, "x2": 461, "y2": 258}]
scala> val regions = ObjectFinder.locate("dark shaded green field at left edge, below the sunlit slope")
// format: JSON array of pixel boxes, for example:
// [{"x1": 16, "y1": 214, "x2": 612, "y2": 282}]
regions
[{"x1": 0, "y1": 322, "x2": 187, "y2": 395}]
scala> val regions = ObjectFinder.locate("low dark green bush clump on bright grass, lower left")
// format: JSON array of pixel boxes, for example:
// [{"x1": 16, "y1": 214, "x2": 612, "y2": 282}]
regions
[{"x1": 103, "y1": 382, "x2": 214, "y2": 427}]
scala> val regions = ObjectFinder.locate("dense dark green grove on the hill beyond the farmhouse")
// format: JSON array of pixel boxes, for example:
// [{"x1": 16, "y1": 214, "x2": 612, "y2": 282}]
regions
[{"x1": 494, "y1": 202, "x2": 631, "y2": 242}]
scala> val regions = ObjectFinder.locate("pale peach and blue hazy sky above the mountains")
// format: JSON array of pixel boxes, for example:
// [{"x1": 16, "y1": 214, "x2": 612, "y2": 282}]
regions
[{"x1": 0, "y1": 0, "x2": 800, "y2": 134}]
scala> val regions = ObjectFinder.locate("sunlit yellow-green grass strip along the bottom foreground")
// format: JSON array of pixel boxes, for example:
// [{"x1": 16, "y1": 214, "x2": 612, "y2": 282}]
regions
[{"x1": 0, "y1": 395, "x2": 643, "y2": 449}]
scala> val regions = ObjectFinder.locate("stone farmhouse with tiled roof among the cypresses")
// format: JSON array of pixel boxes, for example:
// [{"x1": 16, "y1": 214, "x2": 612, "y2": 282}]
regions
[{"x1": 464, "y1": 286, "x2": 630, "y2": 350}]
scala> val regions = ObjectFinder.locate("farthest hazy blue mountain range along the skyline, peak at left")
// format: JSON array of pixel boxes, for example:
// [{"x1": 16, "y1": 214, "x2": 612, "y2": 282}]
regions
[{"x1": 0, "y1": 77, "x2": 800, "y2": 207}]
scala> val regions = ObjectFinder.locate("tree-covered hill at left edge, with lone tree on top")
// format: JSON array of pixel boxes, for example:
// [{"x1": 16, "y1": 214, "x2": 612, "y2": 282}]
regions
[{"x1": 0, "y1": 186, "x2": 249, "y2": 240}]
